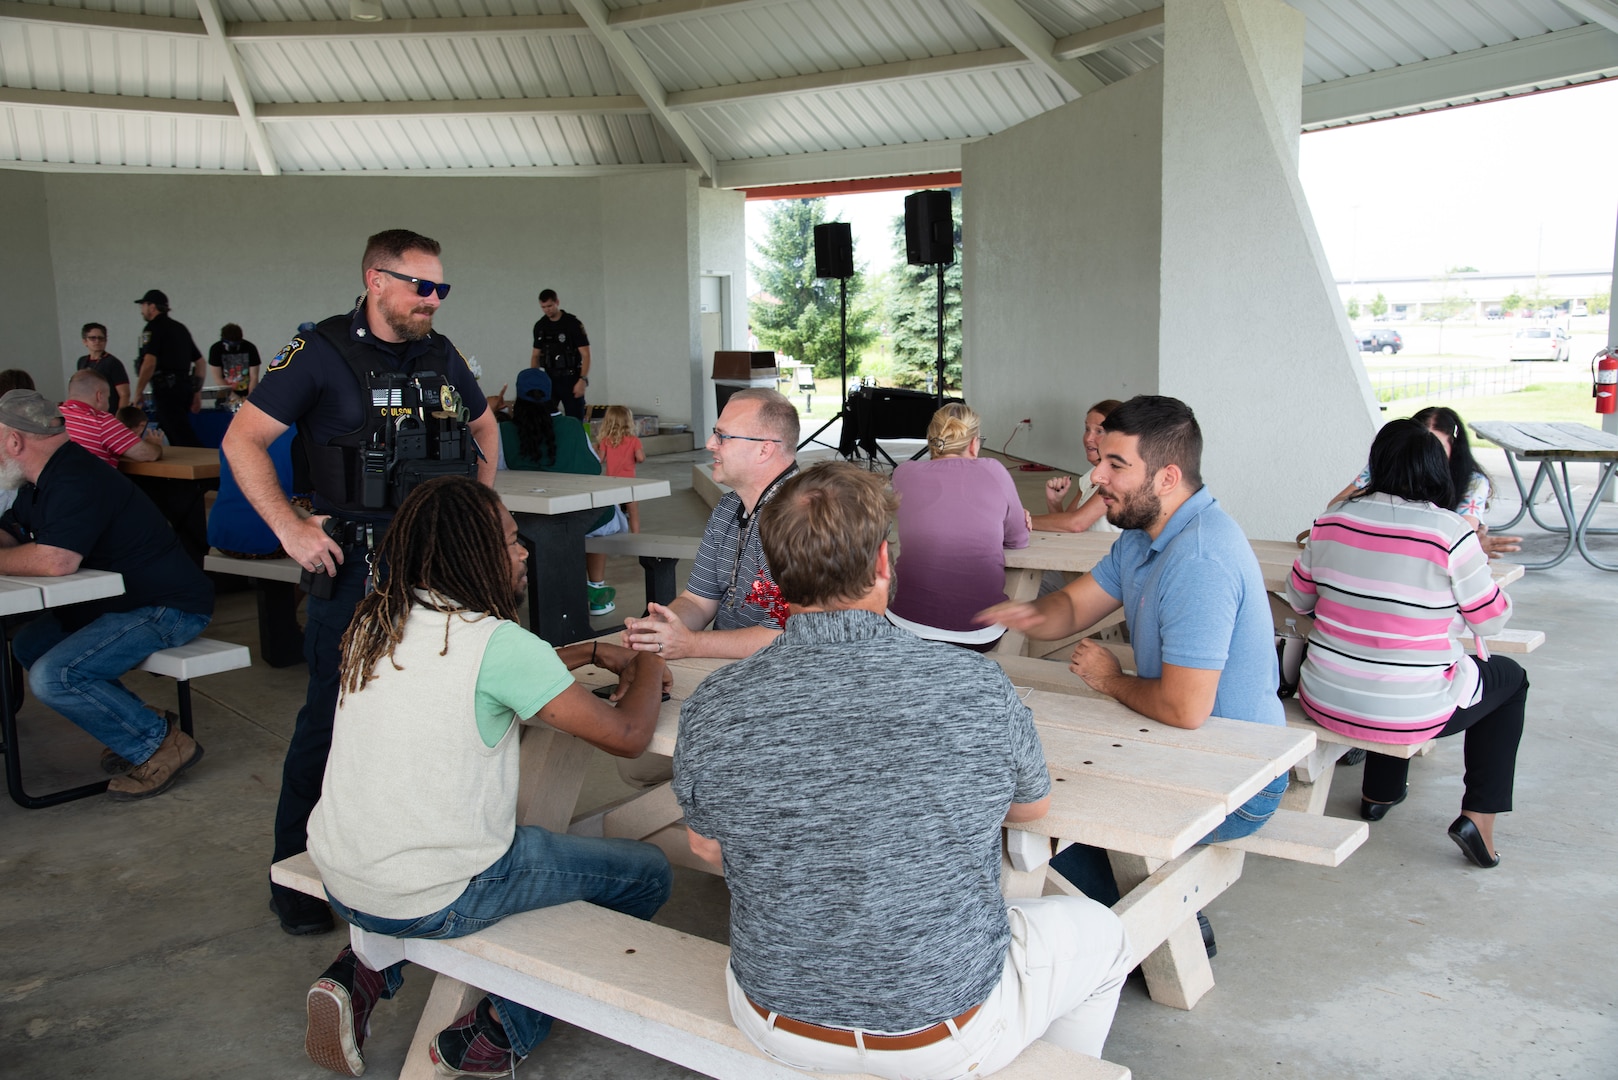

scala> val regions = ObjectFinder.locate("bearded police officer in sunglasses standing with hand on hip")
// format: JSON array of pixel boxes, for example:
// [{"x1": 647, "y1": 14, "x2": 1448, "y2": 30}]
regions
[{"x1": 222, "y1": 228, "x2": 498, "y2": 934}]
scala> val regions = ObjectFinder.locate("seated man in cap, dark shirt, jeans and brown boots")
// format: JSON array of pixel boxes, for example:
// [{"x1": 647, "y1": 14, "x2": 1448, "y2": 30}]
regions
[{"x1": 0, "y1": 390, "x2": 214, "y2": 800}]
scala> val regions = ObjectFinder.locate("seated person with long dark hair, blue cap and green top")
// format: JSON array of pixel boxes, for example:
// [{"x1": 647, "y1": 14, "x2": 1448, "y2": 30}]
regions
[{"x1": 500, "y1": 368, "x2": 625, "y2": 615}]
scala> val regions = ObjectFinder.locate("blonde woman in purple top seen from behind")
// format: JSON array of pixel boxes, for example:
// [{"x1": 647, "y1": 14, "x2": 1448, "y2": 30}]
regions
[{"x1": 888, "y1": 403, "x2": 1027, "y2": 653}]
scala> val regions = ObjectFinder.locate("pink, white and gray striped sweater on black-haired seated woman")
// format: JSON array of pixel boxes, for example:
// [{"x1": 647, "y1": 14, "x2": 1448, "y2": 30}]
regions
[{"x1": 1286, "y1": 494, "x2": 1511, "y2": 743}]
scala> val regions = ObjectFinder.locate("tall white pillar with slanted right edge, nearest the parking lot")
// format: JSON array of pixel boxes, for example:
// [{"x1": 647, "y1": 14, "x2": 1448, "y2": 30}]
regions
[{"x1": 1158, "y1": 0, "x2": 1380, "y2": 539}]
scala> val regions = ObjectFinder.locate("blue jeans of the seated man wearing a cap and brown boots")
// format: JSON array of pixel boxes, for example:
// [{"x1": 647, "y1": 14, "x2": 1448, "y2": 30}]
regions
[{"x1": 11, "y1": 607, "x2": 212, "y2": 764}]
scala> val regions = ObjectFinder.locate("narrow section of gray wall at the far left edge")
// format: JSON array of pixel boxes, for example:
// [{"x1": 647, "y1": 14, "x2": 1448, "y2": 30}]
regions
[{"x1": 0, "y1": 170, "x2": 63, "y2": 397}]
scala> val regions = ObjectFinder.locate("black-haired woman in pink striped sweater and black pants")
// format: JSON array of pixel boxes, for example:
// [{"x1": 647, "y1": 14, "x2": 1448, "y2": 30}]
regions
[{"x1": 1286, "y1": 419, "x2": 1527, "y2": 868}]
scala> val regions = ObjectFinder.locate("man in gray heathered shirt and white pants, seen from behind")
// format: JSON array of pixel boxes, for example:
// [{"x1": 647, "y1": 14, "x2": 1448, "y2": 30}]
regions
[{"x1": 675, "y1": 463, "x2": 1131, "y2": 1080}]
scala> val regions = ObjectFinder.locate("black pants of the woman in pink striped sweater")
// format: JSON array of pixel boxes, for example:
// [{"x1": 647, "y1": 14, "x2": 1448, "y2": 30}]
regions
[{"x1": 1361, "y1": 656, "x2": 1527, "y2": 814}]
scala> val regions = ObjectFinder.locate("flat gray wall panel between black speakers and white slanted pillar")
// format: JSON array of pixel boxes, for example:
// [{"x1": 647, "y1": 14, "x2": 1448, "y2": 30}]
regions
[{"x1": 961, "y1": 68, "x2": 1163, "y2": 471}]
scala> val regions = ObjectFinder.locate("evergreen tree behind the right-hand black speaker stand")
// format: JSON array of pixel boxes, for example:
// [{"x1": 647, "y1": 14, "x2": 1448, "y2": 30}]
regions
[{"x1": 888, "y1": 188, "x2": 961, "y2": 390}]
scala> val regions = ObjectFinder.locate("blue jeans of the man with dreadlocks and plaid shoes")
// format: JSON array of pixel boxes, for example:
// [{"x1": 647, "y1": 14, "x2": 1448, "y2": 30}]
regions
[{"x1": 327, "y1": 826, "x2": 673, "y2": 1057}]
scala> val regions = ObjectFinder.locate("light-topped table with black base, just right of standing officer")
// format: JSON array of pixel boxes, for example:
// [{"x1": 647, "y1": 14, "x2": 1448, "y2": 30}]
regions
[{"x1": 493, "y1": 470, "x2": 670, "y2": 648}]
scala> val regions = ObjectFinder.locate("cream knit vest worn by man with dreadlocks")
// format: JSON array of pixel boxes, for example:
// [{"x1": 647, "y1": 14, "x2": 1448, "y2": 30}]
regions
[{"x1": 309, "y1": 607, "x2": 519, "y2": 918}]
